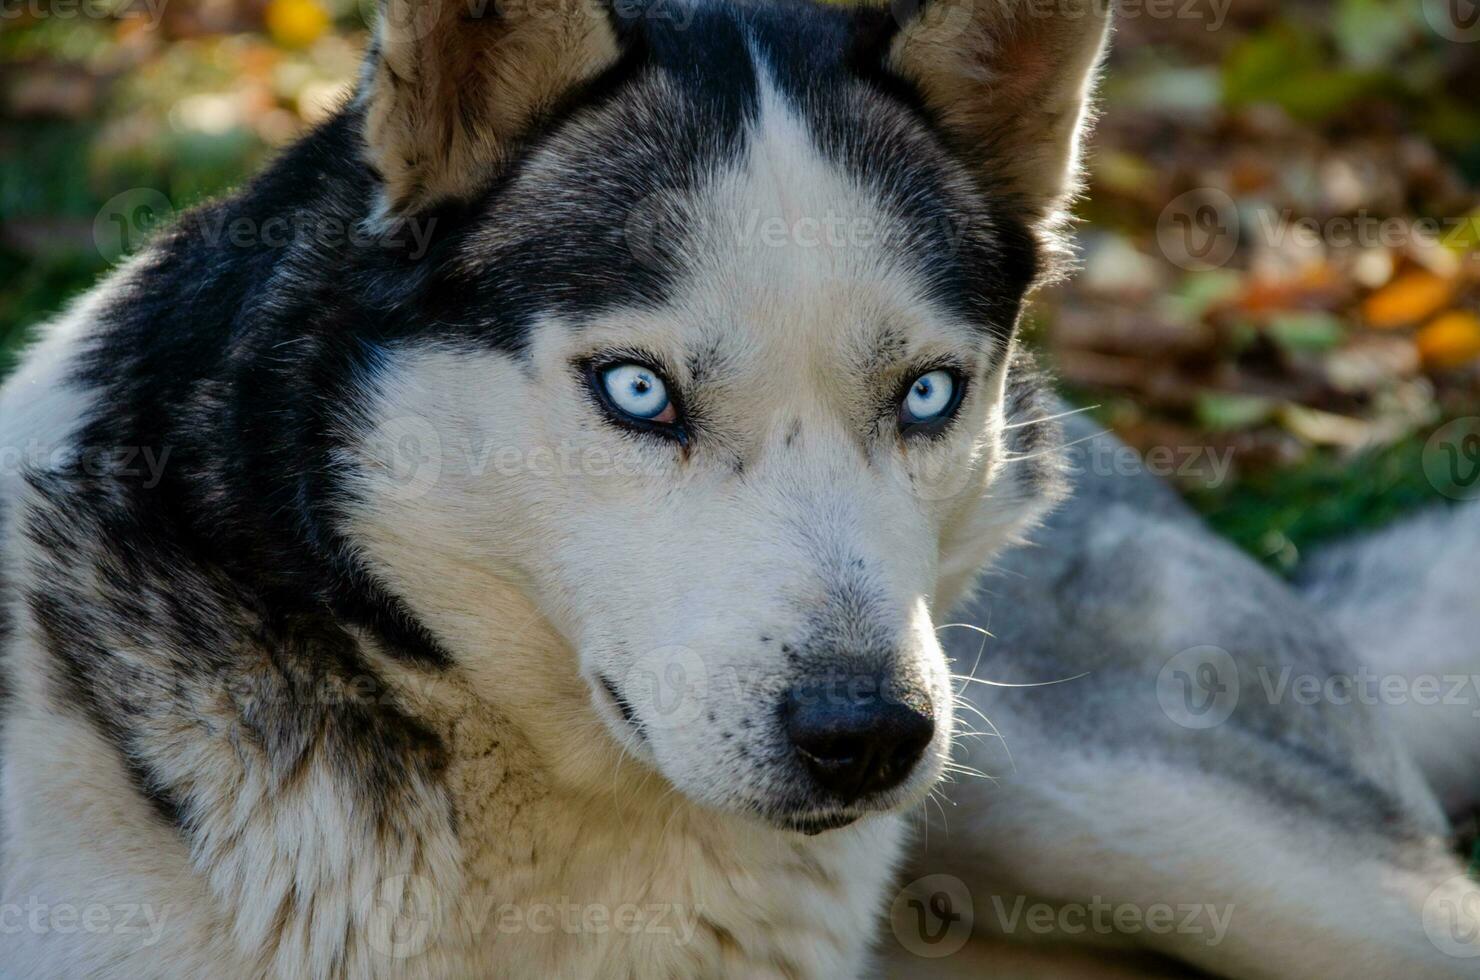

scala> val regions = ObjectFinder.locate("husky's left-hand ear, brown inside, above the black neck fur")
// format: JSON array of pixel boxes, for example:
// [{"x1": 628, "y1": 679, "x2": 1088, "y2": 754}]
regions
[{"x1": 360, "y1": 0, "x2": 620, "y2": 221}]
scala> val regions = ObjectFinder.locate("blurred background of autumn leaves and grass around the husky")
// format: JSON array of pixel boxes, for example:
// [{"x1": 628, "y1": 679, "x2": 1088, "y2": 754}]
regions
[{"x1": 0, "y1": 0, "x2": 1480, "y2": 570}]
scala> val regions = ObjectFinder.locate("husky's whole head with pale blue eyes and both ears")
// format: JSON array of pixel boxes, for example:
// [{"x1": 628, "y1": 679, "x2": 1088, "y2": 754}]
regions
[{"x1": 348, "y1": 0, "x2": 1106, "y2": 832}]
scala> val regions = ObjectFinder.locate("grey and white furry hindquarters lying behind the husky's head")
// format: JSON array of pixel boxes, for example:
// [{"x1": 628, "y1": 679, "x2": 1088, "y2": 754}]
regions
[{"x1": 892, "y1": 420, "x2": 1480, "y2": 979}]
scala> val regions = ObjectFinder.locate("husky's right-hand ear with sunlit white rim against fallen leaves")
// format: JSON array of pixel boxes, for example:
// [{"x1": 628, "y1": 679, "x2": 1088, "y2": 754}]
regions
[{"x1": 885, "y1": 0, "x2": 1110, "y2": 228}]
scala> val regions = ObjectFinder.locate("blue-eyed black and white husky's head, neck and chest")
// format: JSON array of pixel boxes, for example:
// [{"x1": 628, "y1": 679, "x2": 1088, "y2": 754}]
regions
[{"x1": 0, "y1": 0, "x2": 1107, "y2": 979}]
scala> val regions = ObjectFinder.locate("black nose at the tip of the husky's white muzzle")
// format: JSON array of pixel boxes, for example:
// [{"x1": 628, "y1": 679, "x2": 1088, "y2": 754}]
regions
[{"x1": 786, "y1": 684, "x2": 935, "y2": 802}]
